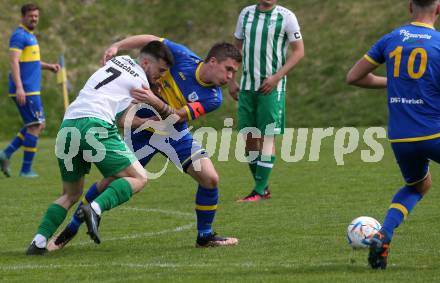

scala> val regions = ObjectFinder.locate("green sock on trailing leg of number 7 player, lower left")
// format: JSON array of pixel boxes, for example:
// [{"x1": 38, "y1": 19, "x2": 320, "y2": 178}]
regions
[{"x1": 37, "y1": 203, "x2": 67, "y2": 242}]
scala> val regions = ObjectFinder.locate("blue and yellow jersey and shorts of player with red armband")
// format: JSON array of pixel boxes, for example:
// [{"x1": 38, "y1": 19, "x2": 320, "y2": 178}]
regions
[{"x1": 131, "y1": 39, "x2": 222, "y2": 172}]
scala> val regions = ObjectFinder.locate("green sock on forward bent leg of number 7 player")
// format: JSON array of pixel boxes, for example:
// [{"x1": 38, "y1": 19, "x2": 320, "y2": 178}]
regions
[{"x1": 94, "y1": 178, "x2": 133, "y2": 212}]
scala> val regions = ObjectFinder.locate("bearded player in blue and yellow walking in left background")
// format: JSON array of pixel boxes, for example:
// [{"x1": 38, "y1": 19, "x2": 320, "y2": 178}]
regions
[{"x1": 0, "y1": 4, "x2": 60, "y2": 178}]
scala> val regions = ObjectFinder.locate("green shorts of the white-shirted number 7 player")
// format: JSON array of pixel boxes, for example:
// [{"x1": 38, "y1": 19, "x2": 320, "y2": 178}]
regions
[{"x1": 55, "y1": 118, "x2": 137, "y2": 182}]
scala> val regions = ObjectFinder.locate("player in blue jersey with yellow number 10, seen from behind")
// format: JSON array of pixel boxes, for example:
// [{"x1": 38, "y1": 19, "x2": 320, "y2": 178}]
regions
[{"x1": 347, "y1": 0, "x2": 440, "y2": 269}]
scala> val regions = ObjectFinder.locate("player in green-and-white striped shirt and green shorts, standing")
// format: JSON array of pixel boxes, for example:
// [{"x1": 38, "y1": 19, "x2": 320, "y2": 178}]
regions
[{"x1": 229, "y1": 0, "x2": 304, "y2": 202}]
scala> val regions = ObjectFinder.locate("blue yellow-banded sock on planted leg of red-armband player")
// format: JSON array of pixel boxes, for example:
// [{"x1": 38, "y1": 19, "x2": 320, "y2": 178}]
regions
[{"x1": 196, "y1": 185, "x2": 218, "y2": 237}]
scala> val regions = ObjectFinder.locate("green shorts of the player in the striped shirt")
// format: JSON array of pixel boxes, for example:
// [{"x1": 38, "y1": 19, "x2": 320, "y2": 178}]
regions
[{"x1": 238, "y1": 90, "x2": 286, "y2": 136}]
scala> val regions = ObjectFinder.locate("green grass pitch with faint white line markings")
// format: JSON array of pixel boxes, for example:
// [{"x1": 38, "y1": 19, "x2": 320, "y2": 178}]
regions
[{"x1": 0, "y1": 134, "x2": 440, "y2": 282}]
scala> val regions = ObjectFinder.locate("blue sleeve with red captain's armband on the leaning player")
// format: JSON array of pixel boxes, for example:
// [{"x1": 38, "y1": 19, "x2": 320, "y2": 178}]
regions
[{"x1": 184, "y1": 88, "x2": 222, "y2": 121}]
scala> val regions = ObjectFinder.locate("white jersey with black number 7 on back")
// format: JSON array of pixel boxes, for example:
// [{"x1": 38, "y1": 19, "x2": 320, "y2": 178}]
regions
[{"x1": 64, "y1": 56, "x2": 149, "y2": 124}]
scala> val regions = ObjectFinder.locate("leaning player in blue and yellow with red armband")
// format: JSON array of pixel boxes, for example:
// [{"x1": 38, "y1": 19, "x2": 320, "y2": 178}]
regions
[{"x1": 49, "y1": 35, "x2": 241, "y2": 250}]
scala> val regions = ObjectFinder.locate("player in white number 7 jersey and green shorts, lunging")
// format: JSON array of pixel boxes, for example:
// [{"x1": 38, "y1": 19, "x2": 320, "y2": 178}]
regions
[{"x1": 27, "y1": 41, "x2": 174, "y2": 255}]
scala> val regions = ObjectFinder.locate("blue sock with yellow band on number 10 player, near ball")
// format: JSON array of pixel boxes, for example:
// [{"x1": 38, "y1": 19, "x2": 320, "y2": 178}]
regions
[{"x1": 382, "y1": 186, "x2": 422, "y2": 240}]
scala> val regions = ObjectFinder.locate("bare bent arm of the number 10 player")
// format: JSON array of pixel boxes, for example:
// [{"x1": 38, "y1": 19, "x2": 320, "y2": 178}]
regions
[{"x1": 346, "y1": 58, "x2": 387, "y2": 88}]
